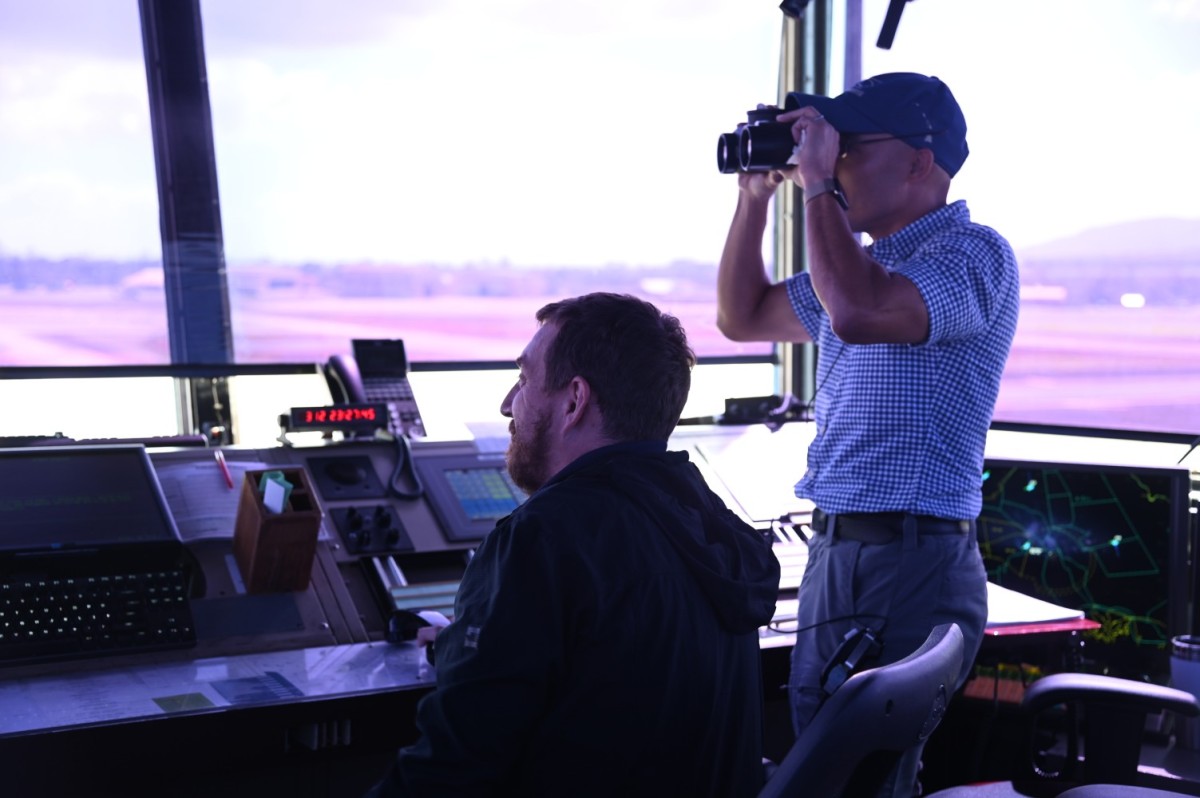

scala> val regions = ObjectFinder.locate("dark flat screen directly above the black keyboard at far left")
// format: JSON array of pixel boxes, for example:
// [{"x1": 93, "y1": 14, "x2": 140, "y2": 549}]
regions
[{"x1": 0, "y1": 445, "x2": 179, "y2": 551}]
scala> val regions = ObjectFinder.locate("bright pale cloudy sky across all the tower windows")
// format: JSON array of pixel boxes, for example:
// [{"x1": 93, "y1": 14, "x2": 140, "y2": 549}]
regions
[{"x1": 0, "y1": 0, "x2": 1200, "y2": 266}]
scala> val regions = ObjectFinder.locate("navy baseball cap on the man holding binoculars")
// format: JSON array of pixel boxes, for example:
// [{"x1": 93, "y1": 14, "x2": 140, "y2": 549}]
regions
[{"x1": 785, "y1": 72, "x2": 968, "y2": 178}]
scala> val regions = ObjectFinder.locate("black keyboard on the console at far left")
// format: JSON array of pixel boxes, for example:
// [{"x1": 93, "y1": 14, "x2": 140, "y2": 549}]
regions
[{"x1": 0, "y1": 569, "x2": 196, "y2": 665}]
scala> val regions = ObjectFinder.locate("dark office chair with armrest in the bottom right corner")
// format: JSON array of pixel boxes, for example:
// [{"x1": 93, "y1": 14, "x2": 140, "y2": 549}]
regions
[{"x1": 928, "y1": 673, "x2": 1200, "y2": 798}]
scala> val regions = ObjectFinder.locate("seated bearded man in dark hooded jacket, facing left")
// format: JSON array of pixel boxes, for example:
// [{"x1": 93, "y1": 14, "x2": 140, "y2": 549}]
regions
[{"x1": 371, "y1": 293, "x2": 779, "y2": 798}]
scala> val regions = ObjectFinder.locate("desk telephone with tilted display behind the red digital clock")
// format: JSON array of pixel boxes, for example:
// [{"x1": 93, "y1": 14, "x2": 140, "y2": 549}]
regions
[{"x1": 325, "y1": 338, "x2": 425, "y2": 438}]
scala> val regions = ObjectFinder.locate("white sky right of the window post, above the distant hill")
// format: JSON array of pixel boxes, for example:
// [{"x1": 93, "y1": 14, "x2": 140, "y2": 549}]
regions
[{"x1": 863, "y1": 0, "x2": 1200, "y2": 247}]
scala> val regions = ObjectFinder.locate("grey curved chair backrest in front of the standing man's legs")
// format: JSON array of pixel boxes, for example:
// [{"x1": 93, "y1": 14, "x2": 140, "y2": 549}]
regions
[{"x1": 758, "y1": 624, "x2": 962, "y2": 798}]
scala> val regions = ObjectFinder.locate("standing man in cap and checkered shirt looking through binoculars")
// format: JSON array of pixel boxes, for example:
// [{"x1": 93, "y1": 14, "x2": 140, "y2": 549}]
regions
[{"x1": 718, "y1": 73, "x2": 1019, "y2": 794}]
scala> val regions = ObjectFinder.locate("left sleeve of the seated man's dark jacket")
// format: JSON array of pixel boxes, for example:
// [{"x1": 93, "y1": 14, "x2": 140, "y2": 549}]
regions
[{"x1": 372, "y1": 517, "x2": 564, "y2": 796}]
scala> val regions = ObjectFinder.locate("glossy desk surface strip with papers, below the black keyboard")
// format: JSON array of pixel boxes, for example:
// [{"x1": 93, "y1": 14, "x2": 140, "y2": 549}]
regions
[{"x1": 0, "y1": 642, "x2": 434, "y2": 738}]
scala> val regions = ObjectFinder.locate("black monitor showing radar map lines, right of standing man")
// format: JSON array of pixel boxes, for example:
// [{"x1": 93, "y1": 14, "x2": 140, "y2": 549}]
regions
[{"x1": 978, "y1": 460, "x2": 1193, "y2": 683}]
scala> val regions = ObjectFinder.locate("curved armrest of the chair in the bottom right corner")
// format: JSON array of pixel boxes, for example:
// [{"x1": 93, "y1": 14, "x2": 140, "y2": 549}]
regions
[{"x1": 1021, "y1": 673, "x2": 1200, "y2": 718}]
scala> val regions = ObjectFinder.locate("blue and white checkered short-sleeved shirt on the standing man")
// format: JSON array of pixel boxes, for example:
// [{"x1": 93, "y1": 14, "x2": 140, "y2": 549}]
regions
[{"x1": 787, "y1": 200, "x2": 1020, "y2": 518}]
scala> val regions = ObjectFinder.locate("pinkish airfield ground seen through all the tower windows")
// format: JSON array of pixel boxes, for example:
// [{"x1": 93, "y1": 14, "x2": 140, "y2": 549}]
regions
[{"x1": 0, "y1": 288, "x2": 1200, "y2": 432}]
